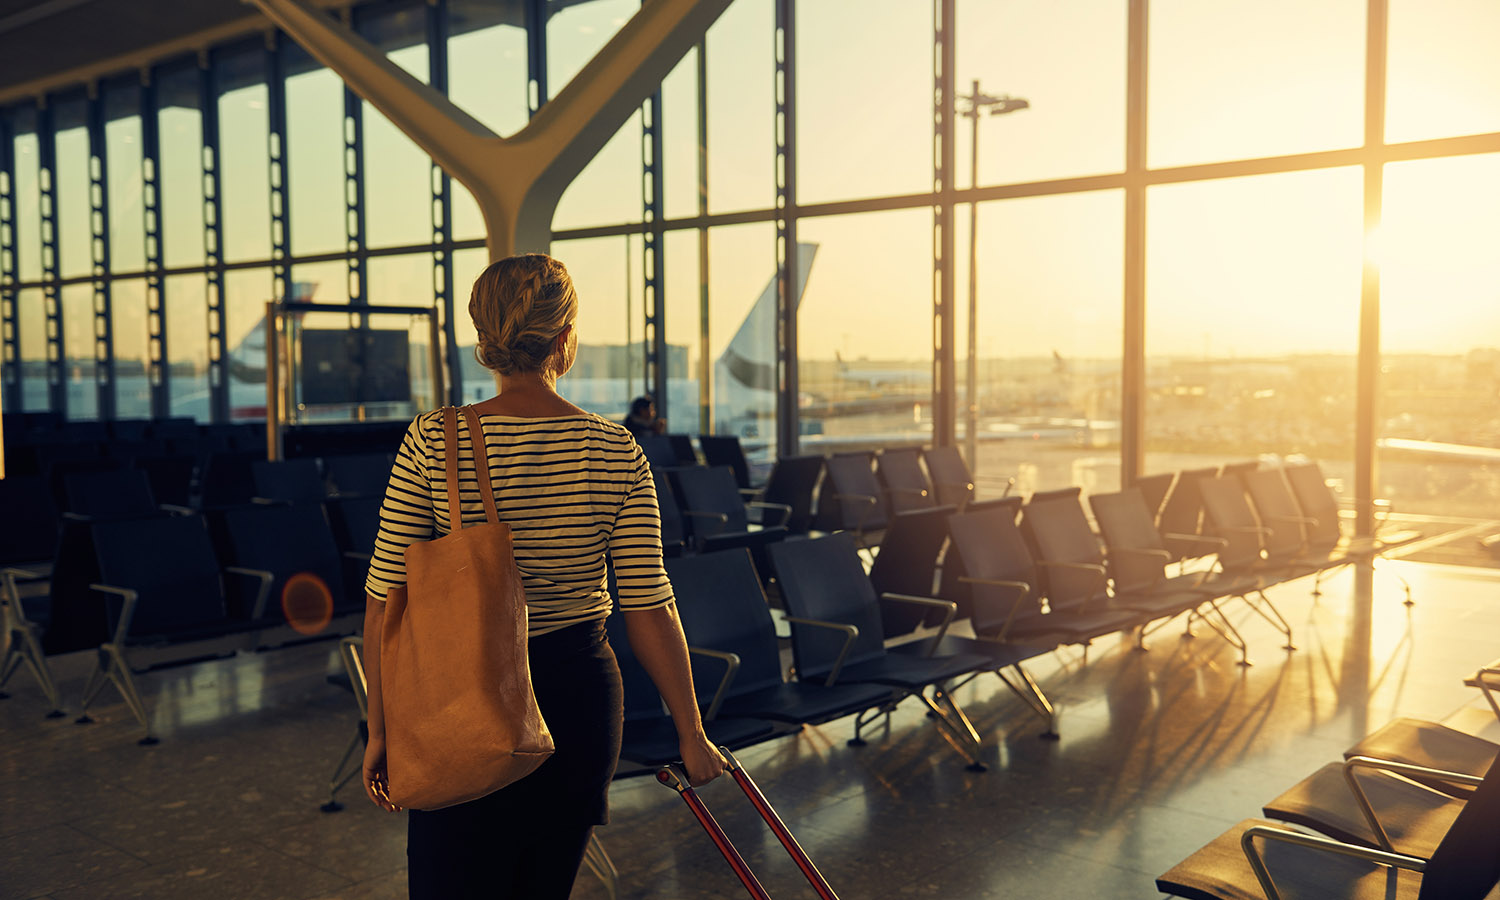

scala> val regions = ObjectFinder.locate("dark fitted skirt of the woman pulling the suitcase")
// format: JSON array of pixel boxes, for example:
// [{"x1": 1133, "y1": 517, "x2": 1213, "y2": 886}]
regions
[{"x1": 407, "y1": 620, "x2": 624, "y2": 899}]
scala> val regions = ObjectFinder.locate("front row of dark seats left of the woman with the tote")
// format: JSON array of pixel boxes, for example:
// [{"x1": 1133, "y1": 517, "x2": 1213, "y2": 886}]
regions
[{"x1": 0, "y1": 470, "x2": 381, "y2": 740}]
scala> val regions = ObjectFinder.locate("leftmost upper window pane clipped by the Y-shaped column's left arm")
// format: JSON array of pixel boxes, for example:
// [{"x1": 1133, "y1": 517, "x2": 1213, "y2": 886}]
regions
[{"x1": 281, "y1": 51, "x2": 348, "y2": 257}]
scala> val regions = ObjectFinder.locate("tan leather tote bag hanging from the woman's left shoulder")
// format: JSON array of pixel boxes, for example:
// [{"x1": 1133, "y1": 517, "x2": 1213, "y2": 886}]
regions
[{"x1": 380, "y1": 407, "x2": 552, "y2": 810}]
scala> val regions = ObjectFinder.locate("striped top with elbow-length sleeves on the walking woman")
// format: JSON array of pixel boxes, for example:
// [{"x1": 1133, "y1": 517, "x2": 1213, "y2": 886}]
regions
[{"x1": 365, "y1": 411, "x2": 672, "y2": 636}]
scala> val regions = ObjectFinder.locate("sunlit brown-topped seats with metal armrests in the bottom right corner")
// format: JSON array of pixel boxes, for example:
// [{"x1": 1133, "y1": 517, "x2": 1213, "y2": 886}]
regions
[{"x1": 1157, "y1": 665, "x2": 1500, "y2": 900}]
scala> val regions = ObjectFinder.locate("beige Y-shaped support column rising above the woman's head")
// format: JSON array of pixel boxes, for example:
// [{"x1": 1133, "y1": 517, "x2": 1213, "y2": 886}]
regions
[{"x1": 249, "y1": 0, "x2": 729, "y2": 260}]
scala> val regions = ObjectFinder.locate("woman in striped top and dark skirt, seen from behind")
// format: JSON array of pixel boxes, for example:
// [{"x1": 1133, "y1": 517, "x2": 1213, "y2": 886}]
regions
[{"x1": 365, "y1": 254, "x2": 725, "y2": 900}]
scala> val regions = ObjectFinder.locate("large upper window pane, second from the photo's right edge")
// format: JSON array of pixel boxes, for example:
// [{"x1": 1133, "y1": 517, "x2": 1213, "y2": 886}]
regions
[{"x1": 1146, "y1": 0, "x2": 1365, "y2": 168}]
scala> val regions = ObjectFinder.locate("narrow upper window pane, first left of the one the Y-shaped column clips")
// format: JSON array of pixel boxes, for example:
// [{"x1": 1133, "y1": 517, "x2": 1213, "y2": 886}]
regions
[{"x1": 215, "y1": 45, "x2": 272, "y2": 263}]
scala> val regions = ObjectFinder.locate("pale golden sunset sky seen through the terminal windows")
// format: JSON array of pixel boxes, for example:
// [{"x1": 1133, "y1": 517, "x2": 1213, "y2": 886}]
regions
[{"x1": 8, "y1": 0, "x2": 1500, "y2": 375}]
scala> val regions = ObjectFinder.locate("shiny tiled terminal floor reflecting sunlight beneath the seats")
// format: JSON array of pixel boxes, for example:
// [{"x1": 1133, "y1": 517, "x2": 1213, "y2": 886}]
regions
[{"x1": 0, "y1": 561, "x2": 1500, "y2": 900}]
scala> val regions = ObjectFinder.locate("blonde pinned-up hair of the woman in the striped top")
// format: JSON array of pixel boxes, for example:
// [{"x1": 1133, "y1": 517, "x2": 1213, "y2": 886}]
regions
[{"x1": 470, "y1": 254, "x2": 578, "y2": 375}]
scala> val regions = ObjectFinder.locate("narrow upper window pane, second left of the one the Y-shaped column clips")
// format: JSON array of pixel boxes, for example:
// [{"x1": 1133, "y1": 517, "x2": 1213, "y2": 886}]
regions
[{"x1": 156, "y1": 65, "x2": 204, "y2": 267}]
